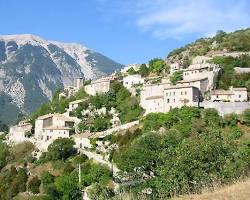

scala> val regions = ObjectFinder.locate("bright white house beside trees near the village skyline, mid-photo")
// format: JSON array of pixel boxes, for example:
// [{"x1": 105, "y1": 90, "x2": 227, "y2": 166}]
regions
[{"x1": 123, "y1": 74, "x2": 144, "y2": 93}]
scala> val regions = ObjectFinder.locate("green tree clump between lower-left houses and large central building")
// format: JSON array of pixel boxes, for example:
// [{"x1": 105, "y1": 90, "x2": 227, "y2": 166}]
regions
[{"x1": 72, "y1": 81, "x2": 143, "y2": 131}]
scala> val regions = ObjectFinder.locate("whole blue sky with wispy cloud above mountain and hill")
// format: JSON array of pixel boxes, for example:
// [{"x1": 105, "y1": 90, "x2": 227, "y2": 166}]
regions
[{"x1": 0, "y1": 0, "x2": 250, "y2": 64}]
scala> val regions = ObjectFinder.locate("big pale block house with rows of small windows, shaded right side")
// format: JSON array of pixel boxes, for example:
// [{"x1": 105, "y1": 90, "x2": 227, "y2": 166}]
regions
[{"x1": 164, "y1": 85, "x2": 202, "y2": 112}]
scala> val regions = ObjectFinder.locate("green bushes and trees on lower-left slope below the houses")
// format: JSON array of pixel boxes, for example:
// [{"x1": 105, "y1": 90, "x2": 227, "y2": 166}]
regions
[{"x1": 0, "y1": 138, "x2": 114, "y2": 200}]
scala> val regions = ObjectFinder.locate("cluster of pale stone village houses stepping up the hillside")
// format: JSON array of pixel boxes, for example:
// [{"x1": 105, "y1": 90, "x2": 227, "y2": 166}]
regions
[{"x1": 8, "y1": 53, "x2": 250, "y2": 151}]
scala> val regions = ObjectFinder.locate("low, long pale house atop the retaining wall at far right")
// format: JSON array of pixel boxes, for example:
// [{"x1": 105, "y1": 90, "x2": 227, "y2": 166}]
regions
[{"x1": 210, "y1": 87, "x2": 248, "y2": 102}]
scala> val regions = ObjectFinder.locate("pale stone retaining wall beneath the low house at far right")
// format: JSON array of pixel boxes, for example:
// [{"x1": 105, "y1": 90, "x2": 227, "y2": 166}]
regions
[{"x1": 200, "y1": 101, "x2": 250, "y2": 116}]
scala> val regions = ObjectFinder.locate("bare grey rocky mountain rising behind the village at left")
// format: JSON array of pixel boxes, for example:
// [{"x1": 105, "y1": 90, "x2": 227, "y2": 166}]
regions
[{"x1": 0, "y1": 34, "x2": 123, "y2": 123}]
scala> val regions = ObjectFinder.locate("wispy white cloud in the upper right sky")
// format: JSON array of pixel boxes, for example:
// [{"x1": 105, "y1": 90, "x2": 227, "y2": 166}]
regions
[{"x1": 136, "y1": 0, "x2": 250, "y2": 38}]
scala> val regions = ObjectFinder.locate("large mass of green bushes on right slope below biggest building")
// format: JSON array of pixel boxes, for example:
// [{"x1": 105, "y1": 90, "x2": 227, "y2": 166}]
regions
[{"x1": 114, "y1": 107, "x2": 250, "y2": 199}]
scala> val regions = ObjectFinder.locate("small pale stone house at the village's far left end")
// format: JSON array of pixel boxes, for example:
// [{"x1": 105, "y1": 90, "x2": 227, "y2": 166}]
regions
[{"x1": 8, "y1": 121, "x2": 32, "y2": 143}]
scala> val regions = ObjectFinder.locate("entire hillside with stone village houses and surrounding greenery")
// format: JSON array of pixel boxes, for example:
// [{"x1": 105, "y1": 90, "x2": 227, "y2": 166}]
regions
[{"x1": 0, "y1": 28, "x2": 250, "y2": 199}]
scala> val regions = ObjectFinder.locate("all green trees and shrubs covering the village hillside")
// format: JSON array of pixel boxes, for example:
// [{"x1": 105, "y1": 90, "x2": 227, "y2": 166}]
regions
[{"x1": 0, "y1": 29, "x2": 250, "y2": 200}]
